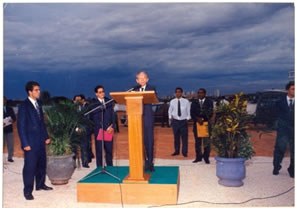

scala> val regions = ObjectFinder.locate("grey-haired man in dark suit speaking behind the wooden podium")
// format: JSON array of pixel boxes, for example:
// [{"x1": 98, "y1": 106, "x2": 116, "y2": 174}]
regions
[{"x1": 133, "y1": 71, "x2": 156, "y2": 171}]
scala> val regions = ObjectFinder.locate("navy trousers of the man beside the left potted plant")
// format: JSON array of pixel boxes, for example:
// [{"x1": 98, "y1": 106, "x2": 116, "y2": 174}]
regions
[{"x1": 23, "y1": 147, "x2": 46, "y2": 195}]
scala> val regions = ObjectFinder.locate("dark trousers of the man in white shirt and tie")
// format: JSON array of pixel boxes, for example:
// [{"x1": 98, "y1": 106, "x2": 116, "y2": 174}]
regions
[{"x1": 171, "y1": 119, "x2": 188, "y2": 155}]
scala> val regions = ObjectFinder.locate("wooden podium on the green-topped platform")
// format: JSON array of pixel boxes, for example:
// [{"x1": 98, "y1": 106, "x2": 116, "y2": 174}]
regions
[{"x1": 110, "y1": 91, "x2": 158, "y2": 183}]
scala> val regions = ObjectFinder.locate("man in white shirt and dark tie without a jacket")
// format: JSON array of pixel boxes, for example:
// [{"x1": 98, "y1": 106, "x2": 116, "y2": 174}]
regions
[{"x1": 168, "y1": 87, "x2": 191, "y2": 157}]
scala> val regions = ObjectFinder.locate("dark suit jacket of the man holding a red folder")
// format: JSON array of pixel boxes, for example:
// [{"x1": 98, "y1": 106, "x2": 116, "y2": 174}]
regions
[{"x1": 90, "y1": 97, "x2": 115, "y2": 138}]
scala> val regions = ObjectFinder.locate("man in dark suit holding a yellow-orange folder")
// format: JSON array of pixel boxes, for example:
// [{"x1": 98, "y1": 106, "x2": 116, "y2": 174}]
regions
[{"x1": 191, "y1": 88, "x2": 213, "y2": 164}]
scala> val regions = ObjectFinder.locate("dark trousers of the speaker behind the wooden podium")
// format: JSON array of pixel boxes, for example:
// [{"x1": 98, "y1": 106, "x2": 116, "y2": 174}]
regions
[{"x1": 143, "y1": 124, "x2": 154, "y2": 167}]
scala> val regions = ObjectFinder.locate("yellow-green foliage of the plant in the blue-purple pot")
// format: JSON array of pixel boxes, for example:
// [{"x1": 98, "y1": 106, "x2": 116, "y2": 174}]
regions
[{"x1": 211, "y1": 93, "x2": 254, "y2": 159}]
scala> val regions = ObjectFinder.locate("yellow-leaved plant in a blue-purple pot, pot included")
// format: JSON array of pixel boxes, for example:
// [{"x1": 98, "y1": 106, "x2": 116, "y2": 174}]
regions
[{"x1": 211, "y1": 93, "x2": 254, "y2": 187}]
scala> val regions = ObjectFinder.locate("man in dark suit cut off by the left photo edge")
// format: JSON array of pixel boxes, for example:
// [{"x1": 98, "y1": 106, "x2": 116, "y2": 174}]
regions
[{"x1": 3, "y1": 96, "x2": 16, "y2": 162}]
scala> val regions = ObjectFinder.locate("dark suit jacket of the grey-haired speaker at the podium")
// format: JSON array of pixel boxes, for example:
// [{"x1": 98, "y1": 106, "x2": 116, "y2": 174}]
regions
[{"x1": 133, "y1": 84, "x2": 157, "y2": 127}]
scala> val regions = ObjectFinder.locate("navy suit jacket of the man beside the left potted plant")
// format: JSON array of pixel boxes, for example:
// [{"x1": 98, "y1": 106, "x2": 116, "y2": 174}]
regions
[{"x1": 17, "y1": 98, "x2": 49, "y2": 151}]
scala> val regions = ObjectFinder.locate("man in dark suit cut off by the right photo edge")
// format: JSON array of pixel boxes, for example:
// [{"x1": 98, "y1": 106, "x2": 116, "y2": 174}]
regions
[{"x1": 272, "y1": 81, "x2": 295, "y2": 178}]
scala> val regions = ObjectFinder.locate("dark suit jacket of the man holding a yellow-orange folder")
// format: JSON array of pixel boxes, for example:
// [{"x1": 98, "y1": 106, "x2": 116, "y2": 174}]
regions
[{"x1": 191, "y1": 98, "x2": 213, "y2": 137}]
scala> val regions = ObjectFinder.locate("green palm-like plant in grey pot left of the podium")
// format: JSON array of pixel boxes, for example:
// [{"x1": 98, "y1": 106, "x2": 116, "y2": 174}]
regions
[{"x1": 45, "y1": 100, "x2": 90, "y2": 185}]
